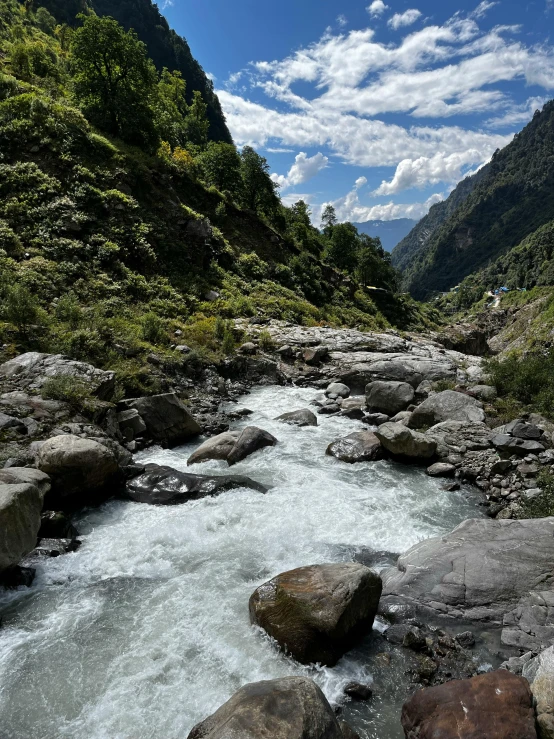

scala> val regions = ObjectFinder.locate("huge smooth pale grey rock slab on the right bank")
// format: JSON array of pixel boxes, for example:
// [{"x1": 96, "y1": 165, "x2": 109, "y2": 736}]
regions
[{"x1": 382, "y1": 518, "x2": 554, "y2": 628}]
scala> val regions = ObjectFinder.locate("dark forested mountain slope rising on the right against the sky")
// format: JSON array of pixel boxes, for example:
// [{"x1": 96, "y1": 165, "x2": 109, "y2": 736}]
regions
[{"x1": 394, "y1": 101, "x2": 554, "y2": 298}]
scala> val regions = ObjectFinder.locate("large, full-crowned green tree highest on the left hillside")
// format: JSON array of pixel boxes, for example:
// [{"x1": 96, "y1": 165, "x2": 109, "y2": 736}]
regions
[{"x1": 71, "y1": 16, "x2": 158, "y2": 147}]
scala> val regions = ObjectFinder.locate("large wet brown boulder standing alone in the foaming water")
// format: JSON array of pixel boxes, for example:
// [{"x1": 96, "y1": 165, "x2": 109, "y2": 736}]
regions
[{"x1": 250, "y1": 563, "x2": 381, "y2": 666}]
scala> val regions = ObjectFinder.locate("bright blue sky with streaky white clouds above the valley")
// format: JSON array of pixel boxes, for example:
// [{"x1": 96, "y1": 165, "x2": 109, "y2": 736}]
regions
[{"x1": 160, "y1": 0, "x2": 554, "y2": 222}]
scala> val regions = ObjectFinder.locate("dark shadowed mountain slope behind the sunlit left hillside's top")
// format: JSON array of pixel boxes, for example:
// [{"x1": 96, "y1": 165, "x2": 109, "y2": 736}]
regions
[{"x1": 35, "y1": 0, "x2": 232, "y2": 143}]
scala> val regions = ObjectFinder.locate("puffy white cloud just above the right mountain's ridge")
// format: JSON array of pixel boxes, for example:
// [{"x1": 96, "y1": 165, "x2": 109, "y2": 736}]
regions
[{"x1": 373, "y1": 149, "x2": 485, "y2": 195}]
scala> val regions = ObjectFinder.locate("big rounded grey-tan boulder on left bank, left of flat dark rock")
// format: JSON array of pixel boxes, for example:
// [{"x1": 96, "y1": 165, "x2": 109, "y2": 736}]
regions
[{"x1": 36, "y1": 434, "x2": 119, "y2": 503}]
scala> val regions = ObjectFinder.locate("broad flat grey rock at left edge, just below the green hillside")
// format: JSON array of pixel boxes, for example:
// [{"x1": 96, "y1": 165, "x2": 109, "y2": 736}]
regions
[{"x1": 0, "y1": 352, "x2": 115, "y2": 400}]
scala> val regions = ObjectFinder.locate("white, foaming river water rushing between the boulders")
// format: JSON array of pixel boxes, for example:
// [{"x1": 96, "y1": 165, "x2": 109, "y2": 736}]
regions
[{"x1": 0, "y1": 387, "x2": 480, "y2": 739}]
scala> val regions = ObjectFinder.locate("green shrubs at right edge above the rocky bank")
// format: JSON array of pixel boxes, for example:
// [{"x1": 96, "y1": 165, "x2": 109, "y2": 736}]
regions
[{"x1": 486, "y1": 349, "x2": 554, "y2": 418}]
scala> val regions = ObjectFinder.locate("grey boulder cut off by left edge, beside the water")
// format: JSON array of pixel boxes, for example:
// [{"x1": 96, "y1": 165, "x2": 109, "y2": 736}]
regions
[{"x1": 0, "y1": 482, "x2": 43, "y2": 572}]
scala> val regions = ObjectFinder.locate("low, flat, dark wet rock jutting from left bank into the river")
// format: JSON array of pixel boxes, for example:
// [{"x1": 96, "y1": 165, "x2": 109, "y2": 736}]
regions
[{"x1": 124, "y1": 464, "x2": 267, "y2": 505}]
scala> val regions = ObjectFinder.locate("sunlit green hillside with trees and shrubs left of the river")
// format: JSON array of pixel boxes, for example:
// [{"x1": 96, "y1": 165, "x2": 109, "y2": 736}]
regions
[{"x1": 0, "y1": 0, "x2": 423, "y2": 393}]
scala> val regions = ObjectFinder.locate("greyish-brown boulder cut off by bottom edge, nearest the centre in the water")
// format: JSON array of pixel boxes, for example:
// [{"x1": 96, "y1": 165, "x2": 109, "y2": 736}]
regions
[{"x1": 188, "y1": 677, "x2": 344, "y2": 739}]
